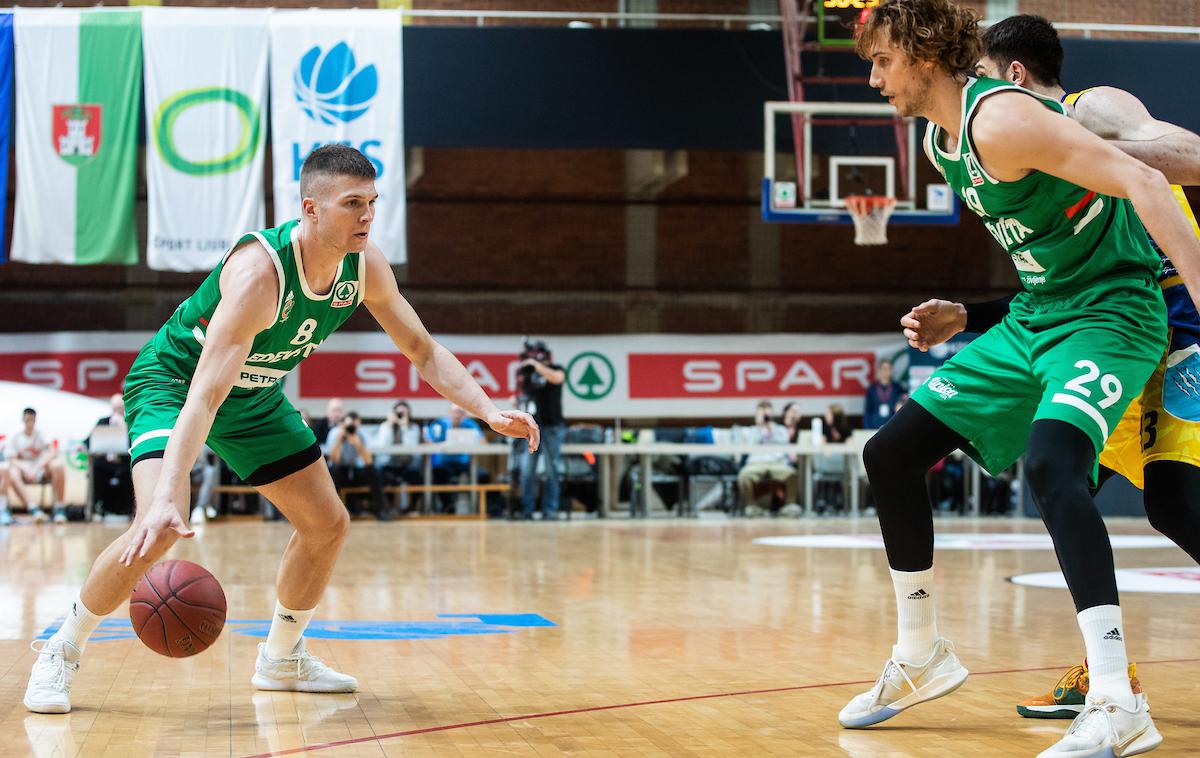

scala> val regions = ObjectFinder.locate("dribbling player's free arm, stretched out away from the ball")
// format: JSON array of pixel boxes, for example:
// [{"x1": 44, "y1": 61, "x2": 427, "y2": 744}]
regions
[{"x1": 362, "y1": 242, "x2": 541, "y2": 451}]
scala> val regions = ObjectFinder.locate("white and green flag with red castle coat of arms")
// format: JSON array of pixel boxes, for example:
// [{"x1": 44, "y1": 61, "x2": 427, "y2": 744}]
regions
[{"x1": 12, "y1": 8, "x2": 142, "y2": 264}]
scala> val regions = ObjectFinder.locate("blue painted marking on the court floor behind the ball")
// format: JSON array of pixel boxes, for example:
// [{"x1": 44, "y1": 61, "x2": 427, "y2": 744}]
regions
[{"x1": 37, "y1": 613, "x2": 558, "y2": 642}]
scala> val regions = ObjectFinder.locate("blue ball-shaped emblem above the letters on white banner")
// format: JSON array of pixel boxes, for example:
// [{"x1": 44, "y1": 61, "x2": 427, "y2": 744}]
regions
[{"x1": 292, "y1": 42, "x2": 379, "y2": 126}]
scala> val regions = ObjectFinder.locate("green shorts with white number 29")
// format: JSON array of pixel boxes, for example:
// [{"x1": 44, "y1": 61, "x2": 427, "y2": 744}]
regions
[{"x1": 912, "y1": 276, "x2": 1166, "y2": 476}]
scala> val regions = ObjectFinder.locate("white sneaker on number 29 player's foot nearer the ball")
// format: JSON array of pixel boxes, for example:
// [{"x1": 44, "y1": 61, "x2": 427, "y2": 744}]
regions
[{"x1": 838, "y1": 637, "x2": 967, "y2": 729}]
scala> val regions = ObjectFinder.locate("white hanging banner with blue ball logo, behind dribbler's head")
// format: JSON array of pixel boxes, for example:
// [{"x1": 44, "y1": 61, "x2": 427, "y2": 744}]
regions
[{"x1": 270, "y1": 8, "x2": 407, "y2": 263}]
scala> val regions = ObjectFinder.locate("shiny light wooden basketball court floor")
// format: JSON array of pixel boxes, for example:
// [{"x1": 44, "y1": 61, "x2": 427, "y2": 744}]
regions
[{"x1": 0, "y1": 519, "x2": 1200, "y2": 758}]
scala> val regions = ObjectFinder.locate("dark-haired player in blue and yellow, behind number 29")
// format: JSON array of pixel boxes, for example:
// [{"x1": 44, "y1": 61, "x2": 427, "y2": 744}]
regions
[{"x1": 900, "y1": 14, "x2": 1200, "y2": 718}]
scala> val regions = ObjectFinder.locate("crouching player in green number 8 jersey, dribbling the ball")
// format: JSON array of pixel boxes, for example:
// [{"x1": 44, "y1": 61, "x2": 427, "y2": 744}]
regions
[{"x1": 25, "y1": 145, "x2": 539, "y2": 714}]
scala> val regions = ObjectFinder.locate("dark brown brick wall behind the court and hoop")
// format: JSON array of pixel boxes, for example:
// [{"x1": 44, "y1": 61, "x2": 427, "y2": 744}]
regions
[{"x1": 0, "y1": 0, "x2": 1200, "y2": 333}]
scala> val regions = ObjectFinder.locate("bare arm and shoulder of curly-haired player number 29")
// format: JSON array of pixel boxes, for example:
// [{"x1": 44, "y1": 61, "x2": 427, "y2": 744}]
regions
[{"x1": 971, "y1": 92, "x2": 1200, "y2": 311}]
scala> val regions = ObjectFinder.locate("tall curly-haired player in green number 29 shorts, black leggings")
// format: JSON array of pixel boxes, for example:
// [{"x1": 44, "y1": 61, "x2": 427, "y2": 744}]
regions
[{"x1": 839, "y1": 0, "x2": 1200, "y2": 757}]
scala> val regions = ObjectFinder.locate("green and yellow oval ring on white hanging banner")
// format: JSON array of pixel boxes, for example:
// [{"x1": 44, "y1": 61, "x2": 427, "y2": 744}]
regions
[{"x1": 154, "y1": 86, "x2": 262, "y2": 176}]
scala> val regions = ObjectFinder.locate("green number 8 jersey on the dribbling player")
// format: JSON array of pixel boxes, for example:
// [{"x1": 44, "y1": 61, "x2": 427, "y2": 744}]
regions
[{"x1": 150, "y1": 221, "x2": 366, "y2": 395}]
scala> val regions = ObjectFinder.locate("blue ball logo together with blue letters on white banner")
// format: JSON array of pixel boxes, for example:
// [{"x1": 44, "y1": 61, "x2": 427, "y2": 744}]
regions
[{"x1": 292, "y1": 41, "x2": 383, "y2": 181}]
